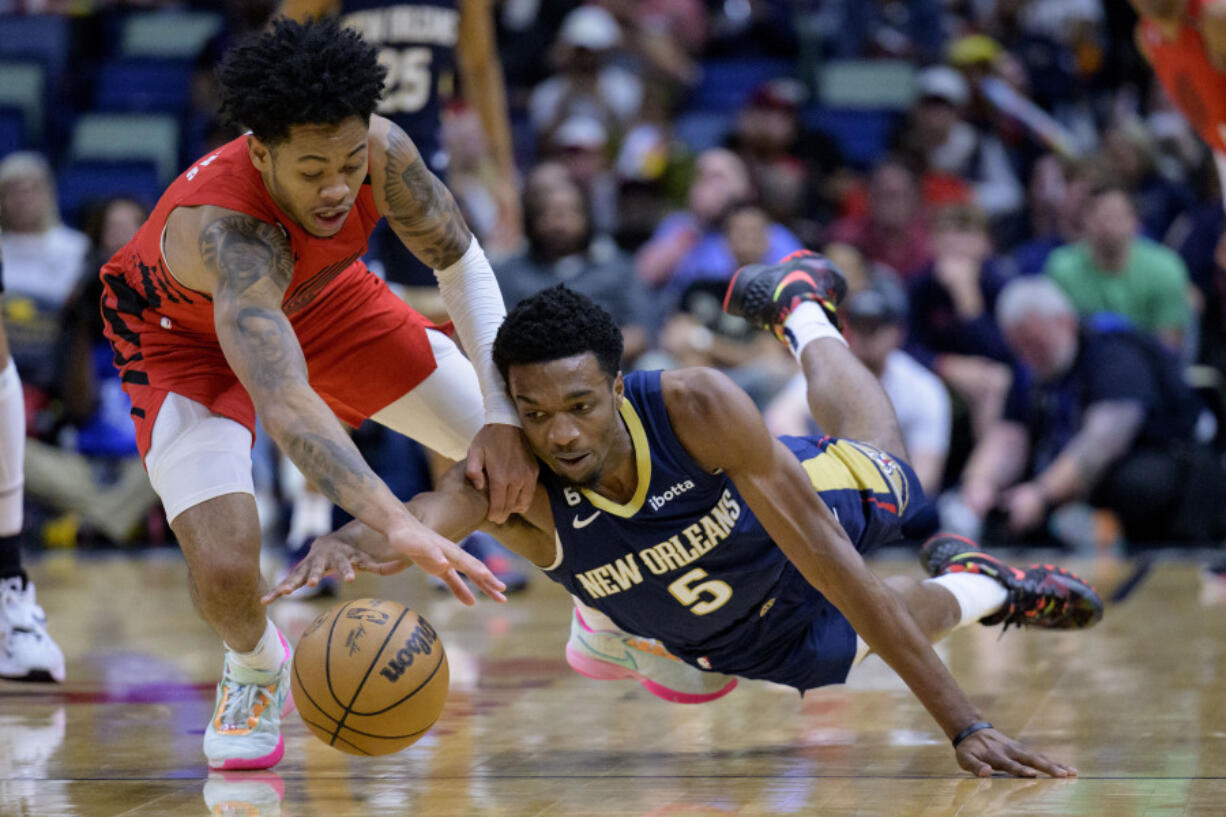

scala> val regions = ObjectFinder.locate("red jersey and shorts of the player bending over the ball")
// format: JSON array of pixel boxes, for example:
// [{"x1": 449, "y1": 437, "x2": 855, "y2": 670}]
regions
[{"x1": 101, "y1": 136, "x2": 435, "y2": 456}]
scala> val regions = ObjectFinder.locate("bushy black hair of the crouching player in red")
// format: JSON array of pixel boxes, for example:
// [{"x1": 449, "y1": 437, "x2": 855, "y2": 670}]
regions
[{"x1": 217, "y1": 17, "x2": 387, "y2": 145}]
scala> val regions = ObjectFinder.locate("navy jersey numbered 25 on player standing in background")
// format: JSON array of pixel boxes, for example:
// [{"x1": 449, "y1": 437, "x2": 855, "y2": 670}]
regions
[{"x1": 341, "y1": 0, "x2": 460, "y2": 172}]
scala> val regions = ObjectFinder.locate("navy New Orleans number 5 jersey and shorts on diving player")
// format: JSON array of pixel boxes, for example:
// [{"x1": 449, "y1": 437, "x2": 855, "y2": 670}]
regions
[{"x1": 541, "y1": 372, "x2": 918, "y2": 689}]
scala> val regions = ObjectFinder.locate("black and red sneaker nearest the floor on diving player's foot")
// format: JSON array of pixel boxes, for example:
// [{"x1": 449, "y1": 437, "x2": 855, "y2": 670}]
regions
[{"x1": 920, "y1": 534, "x2": 1102, "y2": 629}]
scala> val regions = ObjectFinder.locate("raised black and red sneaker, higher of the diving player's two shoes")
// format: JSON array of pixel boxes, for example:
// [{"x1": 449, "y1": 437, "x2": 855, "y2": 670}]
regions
[{"x1": 723, "y1": 250, "x2": 847, "y2": 343}]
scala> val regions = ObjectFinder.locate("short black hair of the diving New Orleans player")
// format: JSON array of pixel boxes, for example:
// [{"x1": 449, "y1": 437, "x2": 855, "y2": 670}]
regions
[{"x1": 494, "y1": 283, "x2": 622, "y2": 380}]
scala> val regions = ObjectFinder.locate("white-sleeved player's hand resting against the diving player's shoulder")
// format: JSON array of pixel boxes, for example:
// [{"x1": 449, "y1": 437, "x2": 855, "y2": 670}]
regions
[{"x1": 465, "y1": 423, "x2": 537, "y2": 522}]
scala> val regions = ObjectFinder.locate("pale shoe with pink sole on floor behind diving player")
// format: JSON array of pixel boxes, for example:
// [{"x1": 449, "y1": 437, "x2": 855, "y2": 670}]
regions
[{"x1": 566, "y1": 608, "x2": 737, "y2": 703}]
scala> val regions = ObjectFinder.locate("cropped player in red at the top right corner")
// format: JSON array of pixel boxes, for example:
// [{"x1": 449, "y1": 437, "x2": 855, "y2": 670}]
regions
[{"x1": 1130, "y1": 0, "x2": 1226, "y2": 190}]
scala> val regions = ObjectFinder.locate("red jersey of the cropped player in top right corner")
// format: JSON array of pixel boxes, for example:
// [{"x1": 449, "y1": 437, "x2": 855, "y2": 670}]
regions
[{"x1": 1137, "y1": 0, "x2": 1226, "y2": 153}]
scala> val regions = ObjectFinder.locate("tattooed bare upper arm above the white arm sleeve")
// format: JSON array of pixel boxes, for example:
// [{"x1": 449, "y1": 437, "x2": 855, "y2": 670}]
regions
[{"x1": 384, "y1": 125, "x2": 472, "y2": 270}]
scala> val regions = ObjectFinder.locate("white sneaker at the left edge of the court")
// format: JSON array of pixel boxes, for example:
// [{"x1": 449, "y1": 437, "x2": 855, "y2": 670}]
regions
[{"x1": 0, "y1": 575, "x2": 64, "y2": 682}]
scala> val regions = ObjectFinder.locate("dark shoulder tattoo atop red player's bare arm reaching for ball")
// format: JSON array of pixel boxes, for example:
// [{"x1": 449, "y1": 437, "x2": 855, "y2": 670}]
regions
[{"x1": 200, "y1": 216, "x2": 294, "y2": 294}]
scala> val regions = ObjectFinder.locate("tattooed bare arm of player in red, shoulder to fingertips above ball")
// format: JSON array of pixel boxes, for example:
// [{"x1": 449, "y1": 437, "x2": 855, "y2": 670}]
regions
[{"x1": 196, "y1": 209, "x2": 501, "y2": 602}]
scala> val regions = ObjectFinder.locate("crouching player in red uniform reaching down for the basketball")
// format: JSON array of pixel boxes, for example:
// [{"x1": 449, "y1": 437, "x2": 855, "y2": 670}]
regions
[{"x1": 102, "y1": 20, "x2": 536, "y2": 769}]
